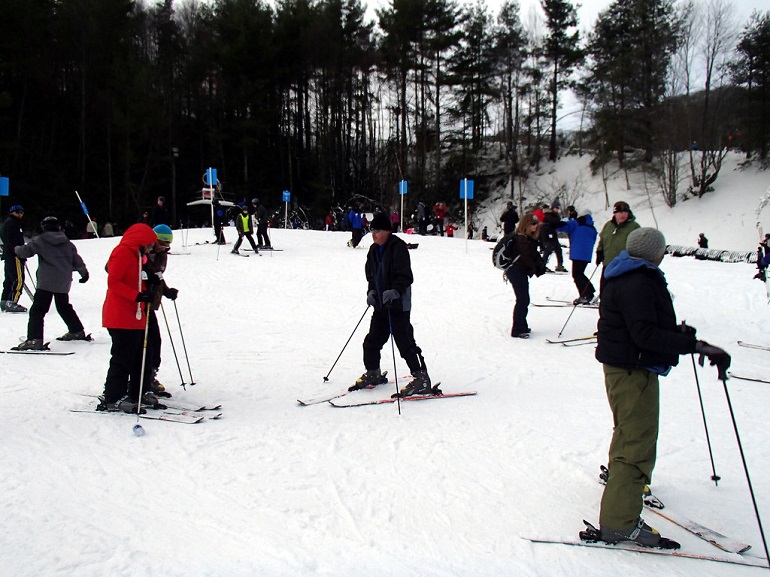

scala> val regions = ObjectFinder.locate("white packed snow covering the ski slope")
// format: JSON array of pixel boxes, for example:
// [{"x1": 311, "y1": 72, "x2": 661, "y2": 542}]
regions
[{"x1": 0, "y1": 151, "x2": 770, "y2": 577}]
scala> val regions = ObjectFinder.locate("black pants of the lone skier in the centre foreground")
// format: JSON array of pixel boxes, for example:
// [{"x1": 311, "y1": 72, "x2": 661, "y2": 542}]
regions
[{"x1": 364, "y1": 309, "x2": 425, "y2": 374}]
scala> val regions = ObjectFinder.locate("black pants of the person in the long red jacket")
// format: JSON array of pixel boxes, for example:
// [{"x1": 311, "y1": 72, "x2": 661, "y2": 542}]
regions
[{"x1": 104, "y1": 329, "x2": 152, "y2": 403}]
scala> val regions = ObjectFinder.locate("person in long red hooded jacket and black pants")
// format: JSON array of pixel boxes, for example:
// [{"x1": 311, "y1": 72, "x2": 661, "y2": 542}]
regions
[{"x1": 97, "y1": 223, "x2": 158, "y2": 413}]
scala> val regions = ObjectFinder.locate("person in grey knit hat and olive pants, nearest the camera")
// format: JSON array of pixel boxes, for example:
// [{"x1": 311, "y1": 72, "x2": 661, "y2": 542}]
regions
[{"x1": 596, "y1": 228, "x2": 730, "y2": 547}]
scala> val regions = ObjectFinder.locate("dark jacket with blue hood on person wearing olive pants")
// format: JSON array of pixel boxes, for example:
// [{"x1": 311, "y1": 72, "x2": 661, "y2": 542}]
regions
[{"x1": 596, "y1": 250, "x2": 696, "y2": 372}]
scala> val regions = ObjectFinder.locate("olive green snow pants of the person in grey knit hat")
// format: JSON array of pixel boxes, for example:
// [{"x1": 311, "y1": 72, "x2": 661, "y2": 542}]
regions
[{"x1": 599, "y1": 365, "x2": 660, "y2": 531}]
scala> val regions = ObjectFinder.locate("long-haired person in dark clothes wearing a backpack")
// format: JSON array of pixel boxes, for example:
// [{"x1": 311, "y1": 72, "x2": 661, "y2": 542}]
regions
[{"x1": 503, "y1": 214, "x2": 545, "y2": 339}]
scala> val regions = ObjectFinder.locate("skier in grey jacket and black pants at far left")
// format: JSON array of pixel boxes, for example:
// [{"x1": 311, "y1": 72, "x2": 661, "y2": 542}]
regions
[{"x1": 13, "y1": 216, "x2": 91, "y2": 351}]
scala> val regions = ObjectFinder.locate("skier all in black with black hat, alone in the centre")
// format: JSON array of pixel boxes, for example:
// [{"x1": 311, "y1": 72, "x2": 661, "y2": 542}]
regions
[{"x1": 349, "y1": 212, "x2": 441, "y2": 397}]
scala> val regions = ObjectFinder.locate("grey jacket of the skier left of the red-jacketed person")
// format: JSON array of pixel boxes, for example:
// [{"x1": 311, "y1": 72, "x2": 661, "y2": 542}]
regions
[{"x1": 16, "y1": 230, "x2": 88, "y2": 293}]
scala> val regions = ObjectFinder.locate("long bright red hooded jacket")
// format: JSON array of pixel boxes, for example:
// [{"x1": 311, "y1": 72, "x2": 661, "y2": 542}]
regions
[{"x1": 102, "y1": 223, "x2": 158, "y2": 330}]
